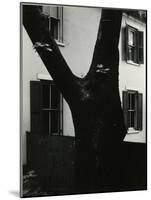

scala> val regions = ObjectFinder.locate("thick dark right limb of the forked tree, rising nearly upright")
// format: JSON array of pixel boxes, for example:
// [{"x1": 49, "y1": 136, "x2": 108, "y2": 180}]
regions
[{"x1": 90, "y1": 9, "x2": 122, "y2": 75}]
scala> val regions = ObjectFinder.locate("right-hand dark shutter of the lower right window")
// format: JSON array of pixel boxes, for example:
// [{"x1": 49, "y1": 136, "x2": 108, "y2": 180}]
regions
[{"x1": 136, "y1": 93, "x2": 143, "y2": 130}]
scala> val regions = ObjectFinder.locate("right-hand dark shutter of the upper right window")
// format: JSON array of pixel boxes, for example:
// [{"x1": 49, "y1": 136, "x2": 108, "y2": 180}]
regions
[{"x1": 138, "y1": 31, "x2": 144, "y2": 64}]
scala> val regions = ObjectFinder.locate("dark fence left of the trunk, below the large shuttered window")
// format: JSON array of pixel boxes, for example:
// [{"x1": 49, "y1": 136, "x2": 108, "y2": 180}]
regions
[{"x1": 27, "y1": 133, "x2": 74, "y2": 192}]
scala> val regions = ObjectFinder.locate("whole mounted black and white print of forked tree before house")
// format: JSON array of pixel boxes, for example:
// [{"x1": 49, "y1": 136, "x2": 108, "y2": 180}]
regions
[{"x1": 20, "y1": 2, "x2": 147, "y2": 197}]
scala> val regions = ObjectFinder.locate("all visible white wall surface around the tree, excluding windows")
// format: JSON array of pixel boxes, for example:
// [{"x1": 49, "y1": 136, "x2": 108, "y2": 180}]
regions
[{"x1": 22, "y1": 7, "x2": 146, "y2": 163}]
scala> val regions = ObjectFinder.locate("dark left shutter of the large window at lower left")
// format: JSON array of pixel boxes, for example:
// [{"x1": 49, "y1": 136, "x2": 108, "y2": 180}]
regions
[{"x1": 30, "y1": 81, "x2": 41, "y2": 134}]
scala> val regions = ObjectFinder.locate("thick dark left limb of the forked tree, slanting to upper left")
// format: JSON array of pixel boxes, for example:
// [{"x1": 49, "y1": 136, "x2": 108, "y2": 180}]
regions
[{"x1": 23, "y1": 5, "x2": 76, "y2": 100}]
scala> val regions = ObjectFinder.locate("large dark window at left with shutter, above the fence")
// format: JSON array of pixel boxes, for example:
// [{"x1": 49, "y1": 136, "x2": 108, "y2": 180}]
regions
[{"x1": 30, "y1": 81, "x2": 63, "y2": 135}]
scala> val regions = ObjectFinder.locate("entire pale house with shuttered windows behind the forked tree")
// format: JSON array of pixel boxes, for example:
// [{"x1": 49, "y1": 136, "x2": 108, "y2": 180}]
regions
[{"x1": 22, "y1": 5, "x2": 146, "y2": 164}]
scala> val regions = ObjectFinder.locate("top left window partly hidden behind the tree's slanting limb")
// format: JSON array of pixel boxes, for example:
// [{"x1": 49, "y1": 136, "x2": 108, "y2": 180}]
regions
[{"x1": 43, "y1": 6, "x2": 63, "y2": 42}]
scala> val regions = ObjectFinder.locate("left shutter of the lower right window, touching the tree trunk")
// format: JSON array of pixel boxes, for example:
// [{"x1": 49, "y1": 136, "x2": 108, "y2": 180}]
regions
[{"x1": 122, "y1": 91, "x2": 128, "y2": 129}]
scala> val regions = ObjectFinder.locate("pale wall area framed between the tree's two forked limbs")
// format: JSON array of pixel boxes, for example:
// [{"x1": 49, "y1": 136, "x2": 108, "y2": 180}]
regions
[{"x1": 59, "y1": 7, "x2": 101, "y2": 76}]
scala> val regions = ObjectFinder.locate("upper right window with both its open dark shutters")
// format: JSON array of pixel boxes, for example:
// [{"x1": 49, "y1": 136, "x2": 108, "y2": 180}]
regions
[{"x1": 125, "y1": 25, "x2": 144, "y2": 64}]
